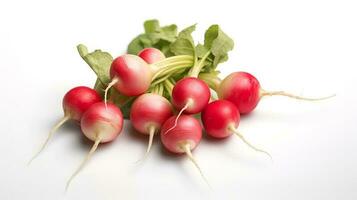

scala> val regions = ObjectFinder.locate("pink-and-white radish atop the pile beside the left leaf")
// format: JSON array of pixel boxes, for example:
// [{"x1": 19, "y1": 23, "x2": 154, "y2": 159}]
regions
[{"x1": 104, "y1": 54, "x2": 153, "y2": 102}]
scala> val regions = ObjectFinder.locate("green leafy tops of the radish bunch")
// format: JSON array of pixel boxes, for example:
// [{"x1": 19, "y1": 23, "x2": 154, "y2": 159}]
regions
[{"x1": 77, "y1": 19, "x2": 234, "y2": 118}]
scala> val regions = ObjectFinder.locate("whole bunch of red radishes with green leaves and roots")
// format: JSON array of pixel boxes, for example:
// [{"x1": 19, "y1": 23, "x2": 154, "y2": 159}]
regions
[{"x1": 30, "y1": 20, "x2": 332, "y2": 190}]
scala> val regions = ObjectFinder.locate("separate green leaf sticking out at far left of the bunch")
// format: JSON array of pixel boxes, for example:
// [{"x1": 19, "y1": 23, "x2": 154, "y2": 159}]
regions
[{"x1": 77, "y1": 44, "x2": 113, "y2": 85}]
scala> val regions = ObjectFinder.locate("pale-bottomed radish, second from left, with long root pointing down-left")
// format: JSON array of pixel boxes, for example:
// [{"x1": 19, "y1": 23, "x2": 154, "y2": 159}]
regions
[{"x1": 66, "y1": 102, "x2": 123, "y2": 189}]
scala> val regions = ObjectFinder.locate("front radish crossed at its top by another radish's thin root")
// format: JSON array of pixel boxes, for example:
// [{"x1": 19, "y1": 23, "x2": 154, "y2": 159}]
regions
[{"x1": 160, "y1": 115, "x2": 208, "y2": 183}]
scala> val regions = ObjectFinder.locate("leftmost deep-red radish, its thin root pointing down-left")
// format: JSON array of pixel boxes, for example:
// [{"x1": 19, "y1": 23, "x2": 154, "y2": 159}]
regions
[{"x1": 29, "y1": 86, "x2": 101, "y2": 164}]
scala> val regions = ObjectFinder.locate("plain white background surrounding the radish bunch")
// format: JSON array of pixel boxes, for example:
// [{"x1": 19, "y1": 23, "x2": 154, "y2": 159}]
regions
[{"x1": 0, "y1": 0, "x2": 357, "y2": 200}]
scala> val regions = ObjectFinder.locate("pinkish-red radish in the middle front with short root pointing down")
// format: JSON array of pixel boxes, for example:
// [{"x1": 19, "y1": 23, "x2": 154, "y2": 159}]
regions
[{"x1": 130, "y1": 93, "x2": 173, "y2": 158}]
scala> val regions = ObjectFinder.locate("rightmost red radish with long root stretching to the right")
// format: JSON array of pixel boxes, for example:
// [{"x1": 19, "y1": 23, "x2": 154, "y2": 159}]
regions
[{"x1": 218, "y1": 72, "x2": 335, "y2": 114}]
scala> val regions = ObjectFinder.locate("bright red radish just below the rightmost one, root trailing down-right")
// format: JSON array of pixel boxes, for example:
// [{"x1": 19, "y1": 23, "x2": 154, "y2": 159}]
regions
[{"x1": 201, "y1": 100, "x2": 272, "y2": 158}]
